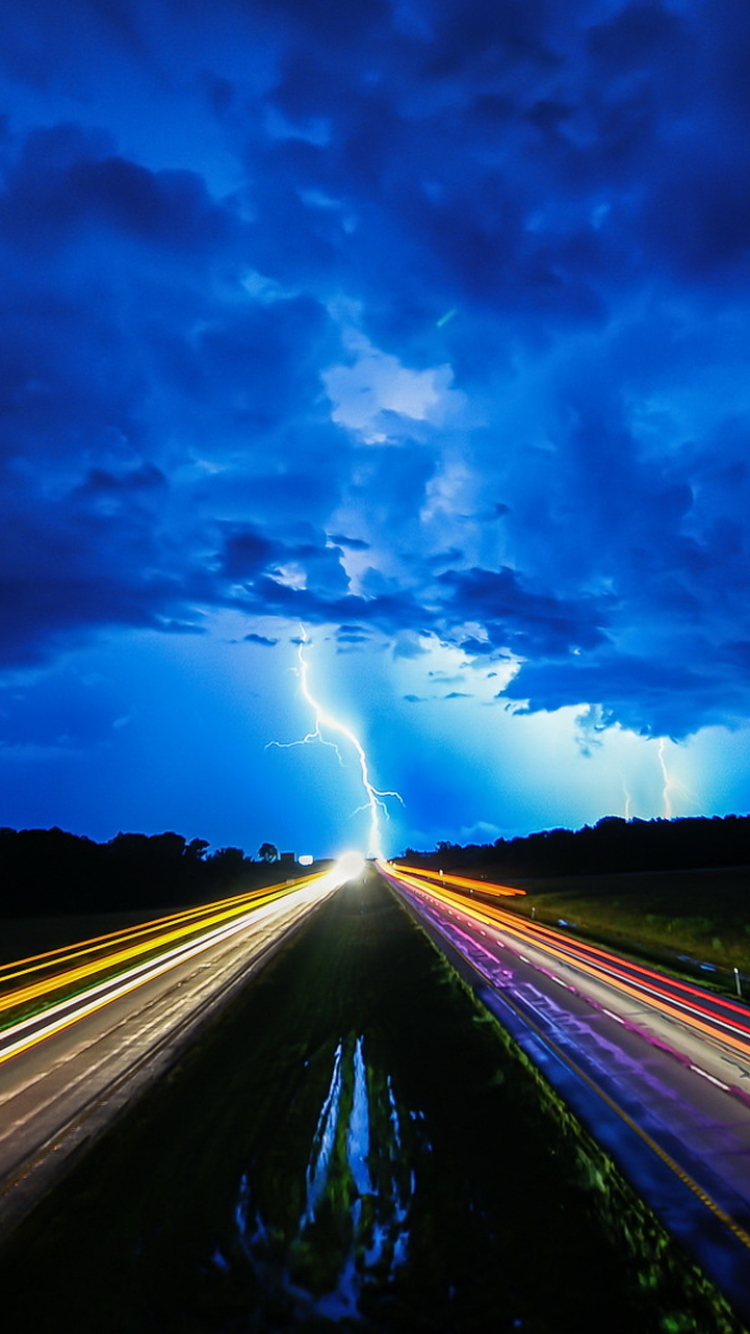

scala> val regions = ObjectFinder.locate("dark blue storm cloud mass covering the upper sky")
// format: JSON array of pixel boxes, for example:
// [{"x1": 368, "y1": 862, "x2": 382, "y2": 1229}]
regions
[{"x1": 0, "y1": 0, "x2": 750, "y2": 757}]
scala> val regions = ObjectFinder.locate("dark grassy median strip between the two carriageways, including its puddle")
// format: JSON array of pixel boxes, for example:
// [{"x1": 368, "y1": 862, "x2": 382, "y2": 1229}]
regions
[{"x1": 0, "y1": 872, "x2": 742, "y2": 1334}]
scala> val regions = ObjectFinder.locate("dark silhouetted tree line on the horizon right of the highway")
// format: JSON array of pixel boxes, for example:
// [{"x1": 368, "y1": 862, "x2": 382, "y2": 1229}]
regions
[{"x1": 403, "y1": 815, "x2": 750, "y2": 879}]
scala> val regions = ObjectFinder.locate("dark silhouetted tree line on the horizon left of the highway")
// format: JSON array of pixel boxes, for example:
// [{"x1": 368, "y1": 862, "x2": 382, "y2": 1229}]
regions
[{"x1": 0, "y1": 828, "x2": 285, "y2": 918}]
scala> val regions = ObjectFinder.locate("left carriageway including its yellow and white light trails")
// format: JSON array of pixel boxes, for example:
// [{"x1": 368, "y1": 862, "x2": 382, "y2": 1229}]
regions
[{"x1": 0, "y1": 867, "x2": 348, "y2": 1234}]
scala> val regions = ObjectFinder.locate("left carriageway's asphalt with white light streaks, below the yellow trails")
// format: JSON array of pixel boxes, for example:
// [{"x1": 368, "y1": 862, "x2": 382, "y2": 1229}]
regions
[{"x1": 0, "y1": 876, "x2": 336, "y2": 1233}]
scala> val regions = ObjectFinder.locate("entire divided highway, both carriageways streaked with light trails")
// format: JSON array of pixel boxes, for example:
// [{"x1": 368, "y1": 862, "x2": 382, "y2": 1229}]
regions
[{"x1": 0, "y1": 862, "x2": 750, "y2": 1319}]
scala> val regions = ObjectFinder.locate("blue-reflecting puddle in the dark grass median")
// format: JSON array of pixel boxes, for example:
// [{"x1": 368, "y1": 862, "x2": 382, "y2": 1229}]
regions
[{"x1": 212, "y1": 1035, "x2": 421, "y2": 1321}]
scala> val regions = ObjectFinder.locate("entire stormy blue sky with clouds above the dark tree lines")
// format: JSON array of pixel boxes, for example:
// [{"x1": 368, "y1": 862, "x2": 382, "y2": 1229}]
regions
[{"x1": 0, "y1": 0, "x2": 750, "y2": 855}]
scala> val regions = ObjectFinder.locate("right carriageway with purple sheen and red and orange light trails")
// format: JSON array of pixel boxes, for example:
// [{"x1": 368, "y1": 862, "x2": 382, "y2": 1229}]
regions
[{"x1": 378, "y1": 862, "x2": 750, "y2": 1319}]
